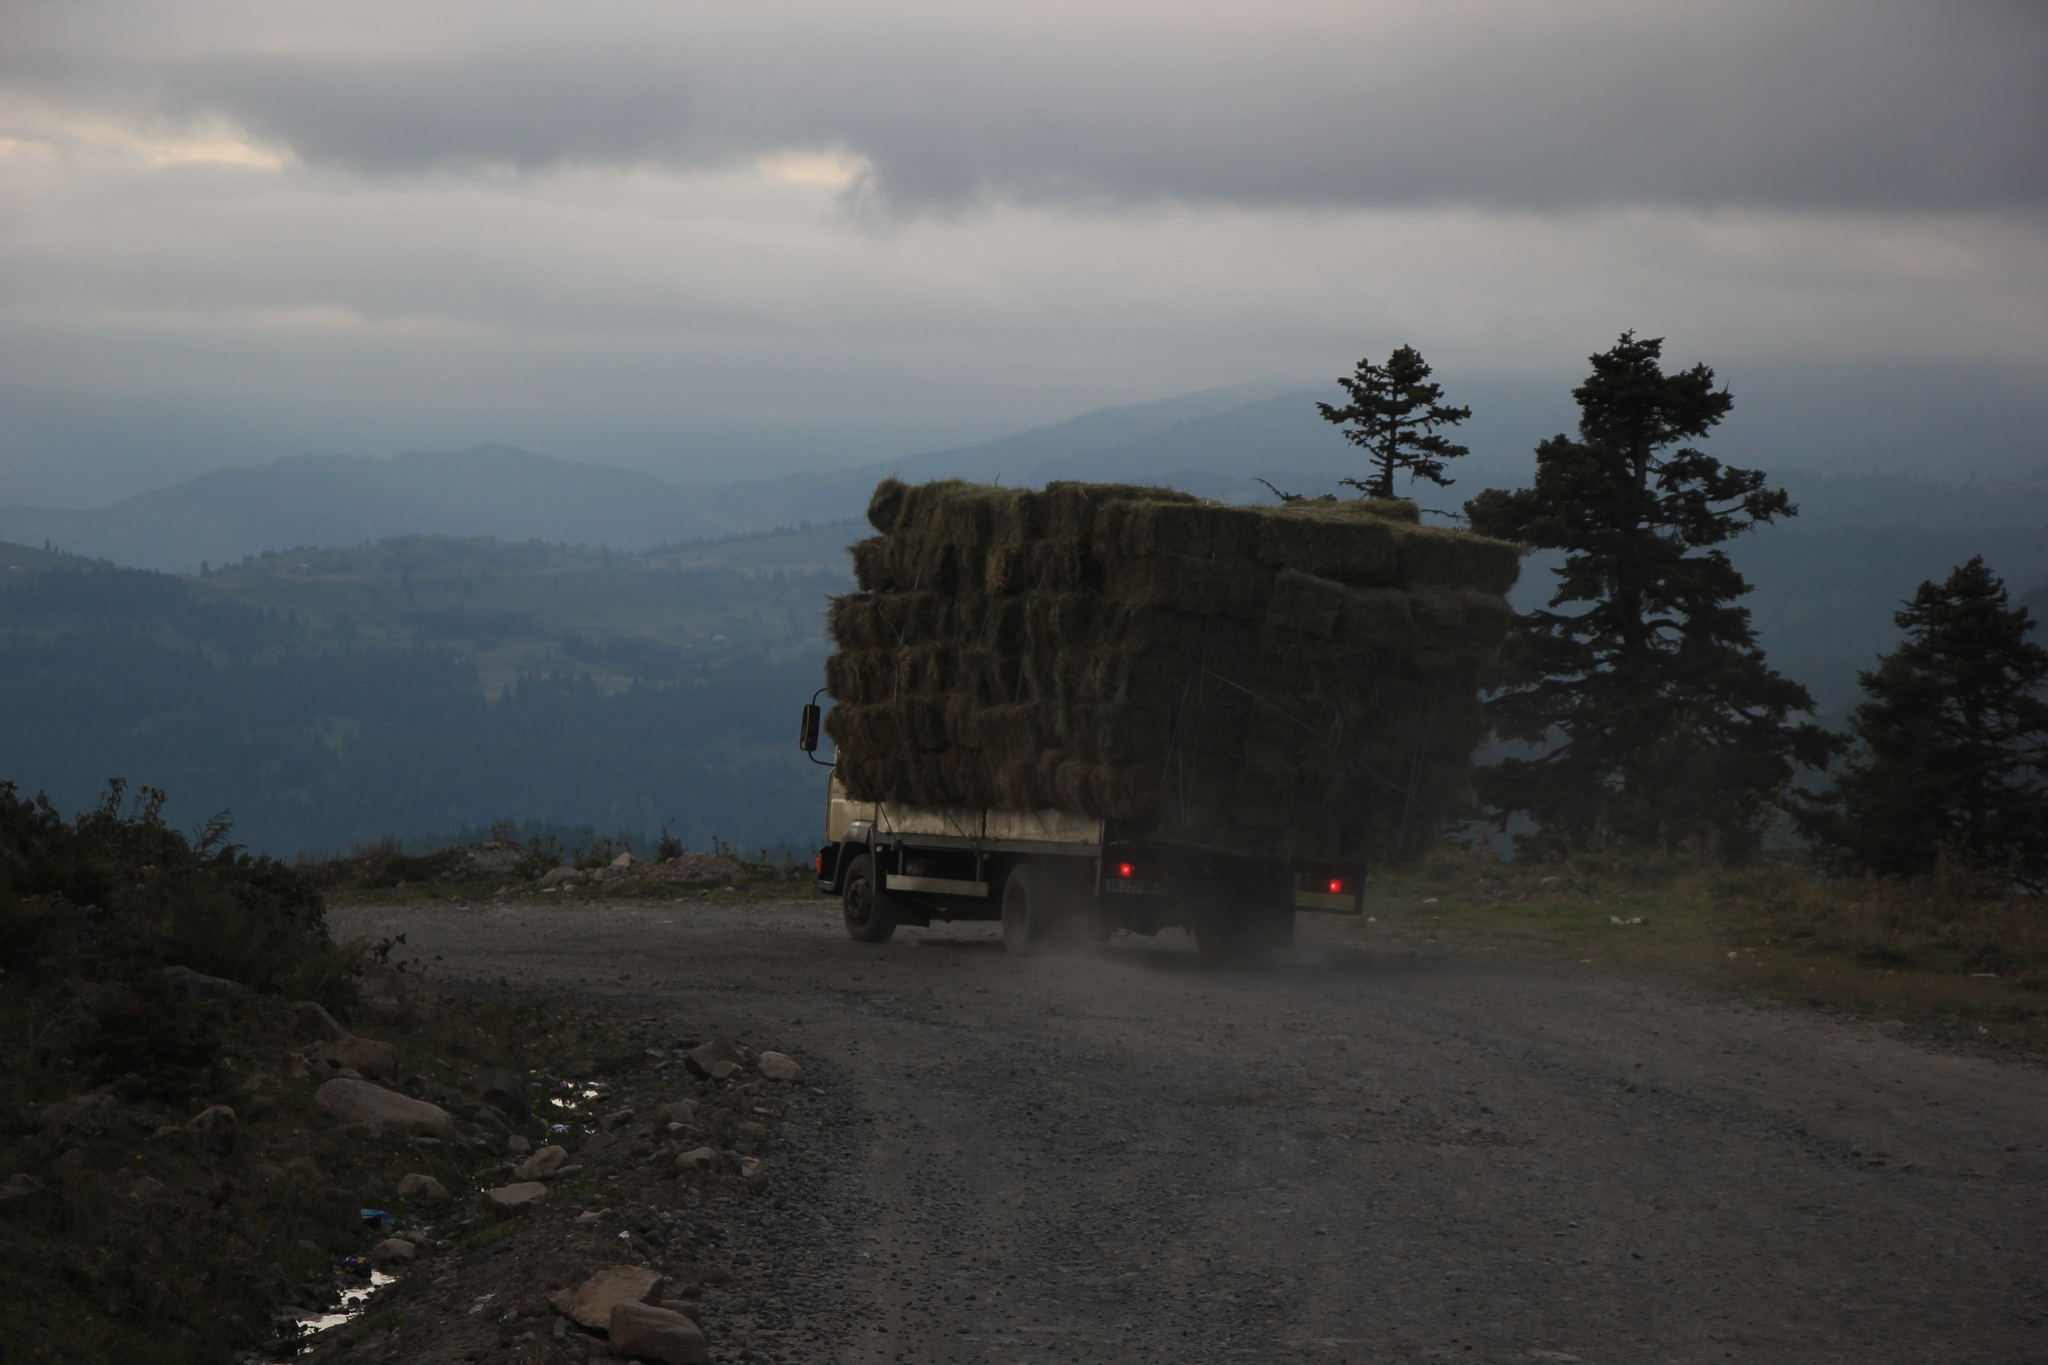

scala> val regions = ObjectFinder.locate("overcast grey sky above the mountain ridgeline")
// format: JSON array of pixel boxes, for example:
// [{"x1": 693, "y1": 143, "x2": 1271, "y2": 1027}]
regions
[{"x1": 0, "y1": 0, "x2": 2048, "y2": 505}]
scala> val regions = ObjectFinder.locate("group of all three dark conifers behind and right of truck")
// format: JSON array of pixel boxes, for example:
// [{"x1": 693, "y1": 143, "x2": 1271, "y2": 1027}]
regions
[{"x1": 1319, "y1": 332, "x2": 2048, "y2": 886}]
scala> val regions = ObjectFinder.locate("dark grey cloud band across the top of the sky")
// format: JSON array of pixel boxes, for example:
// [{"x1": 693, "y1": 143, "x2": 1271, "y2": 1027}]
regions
[{"x1": 10, "y1": 0, "x2": 2048, "y2": 211}]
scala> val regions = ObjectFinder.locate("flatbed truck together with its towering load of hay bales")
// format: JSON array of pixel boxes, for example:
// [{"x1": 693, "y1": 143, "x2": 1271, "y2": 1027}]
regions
[{"x1": 799, "y1": 479, "x2": 1520, "y2": 956}]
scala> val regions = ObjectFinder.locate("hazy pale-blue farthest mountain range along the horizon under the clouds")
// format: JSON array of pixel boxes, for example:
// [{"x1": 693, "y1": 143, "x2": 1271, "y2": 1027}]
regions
[{"x1": 16, "y1": 362, "x2": 2048, "y2": 573}]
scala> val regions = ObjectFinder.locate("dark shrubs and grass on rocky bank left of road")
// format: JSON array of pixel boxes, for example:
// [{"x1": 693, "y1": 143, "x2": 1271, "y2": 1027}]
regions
[{"x1": 0, "y1": 784, "x2": 623, "y2": 1363}]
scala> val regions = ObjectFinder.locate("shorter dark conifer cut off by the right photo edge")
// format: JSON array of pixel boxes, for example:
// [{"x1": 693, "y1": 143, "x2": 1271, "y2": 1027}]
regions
[{"x1": 1804, "y1": 557, "x2": 2048, "y2": 884}]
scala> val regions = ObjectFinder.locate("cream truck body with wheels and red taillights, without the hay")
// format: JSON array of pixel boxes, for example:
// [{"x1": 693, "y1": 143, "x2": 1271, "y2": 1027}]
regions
[{"x1": 799, "y1": 702, "x2": 1366, "y2": 958}]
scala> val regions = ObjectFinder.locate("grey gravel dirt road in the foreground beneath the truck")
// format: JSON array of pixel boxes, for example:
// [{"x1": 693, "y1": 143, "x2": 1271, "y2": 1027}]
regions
[{"x1": 332, "y1": 900, "x2": 2048, "y2": 1365}]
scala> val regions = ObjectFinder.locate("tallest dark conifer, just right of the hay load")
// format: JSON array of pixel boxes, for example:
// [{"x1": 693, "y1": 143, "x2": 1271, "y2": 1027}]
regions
[{"x1": 1466, "y1": 332, "x2": 1839, "y2": 857}]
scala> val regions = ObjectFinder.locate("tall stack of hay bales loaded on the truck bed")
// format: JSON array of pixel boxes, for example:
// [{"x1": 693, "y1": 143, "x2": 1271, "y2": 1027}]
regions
[{"x1": 825, "y1": 479, "x2": 1520, "y2": 862}]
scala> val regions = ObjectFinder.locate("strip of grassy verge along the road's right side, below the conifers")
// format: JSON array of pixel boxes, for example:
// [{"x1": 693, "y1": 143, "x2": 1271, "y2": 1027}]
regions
[{"x1": 1327, "y1": 851, "x2": 2048, "y2": 1058}]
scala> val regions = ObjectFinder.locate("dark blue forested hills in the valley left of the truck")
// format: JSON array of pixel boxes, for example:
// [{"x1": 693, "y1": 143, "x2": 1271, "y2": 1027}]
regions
[{"x1": 0, "y1": 542, "x2": 846, "y2": 855}]
